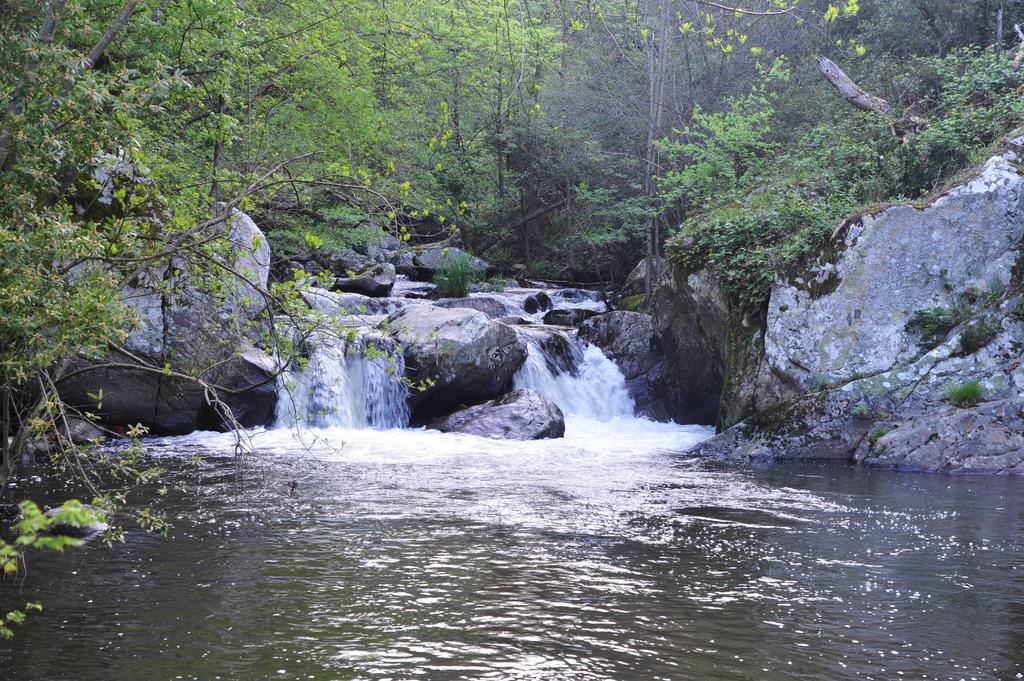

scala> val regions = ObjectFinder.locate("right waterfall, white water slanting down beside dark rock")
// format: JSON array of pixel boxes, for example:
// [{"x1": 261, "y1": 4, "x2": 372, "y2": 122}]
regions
[{"x1": 512, "y1": 334, "x2": 635, "y2": 421}]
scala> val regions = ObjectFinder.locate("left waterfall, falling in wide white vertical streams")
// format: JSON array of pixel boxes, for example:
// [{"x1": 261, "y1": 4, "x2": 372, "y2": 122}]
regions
[{"x1": 275, "y1": 335, "x2": 409, "y2": 428}]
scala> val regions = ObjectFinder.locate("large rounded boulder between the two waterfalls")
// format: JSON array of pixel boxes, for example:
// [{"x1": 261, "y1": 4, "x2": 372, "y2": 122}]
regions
[{"x1": 386, "y1": 305, "x2": 526, "y2": 419}]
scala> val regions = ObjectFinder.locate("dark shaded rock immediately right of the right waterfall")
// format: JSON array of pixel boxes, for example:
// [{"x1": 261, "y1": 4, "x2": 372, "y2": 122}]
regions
[{"x1": 580, "y1": 310, "x2": 676, "y2": 420}]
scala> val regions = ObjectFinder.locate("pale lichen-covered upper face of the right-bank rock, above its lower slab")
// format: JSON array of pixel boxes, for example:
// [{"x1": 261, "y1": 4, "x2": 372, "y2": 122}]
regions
[{"x1": 765, "y1": 152, "x2": 1024, "y2": 389}]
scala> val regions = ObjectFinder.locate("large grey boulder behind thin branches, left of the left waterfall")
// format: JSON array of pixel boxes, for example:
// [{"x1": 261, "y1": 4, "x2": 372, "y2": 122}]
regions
[{"x1": 57, "y1": 210, "x2": 272, "y2": 434}]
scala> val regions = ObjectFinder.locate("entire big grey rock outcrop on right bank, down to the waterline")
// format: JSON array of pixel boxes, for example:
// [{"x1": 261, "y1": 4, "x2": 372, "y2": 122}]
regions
[{"x1": 696, "y1": 139, "x2": 1024, "y2": 473}]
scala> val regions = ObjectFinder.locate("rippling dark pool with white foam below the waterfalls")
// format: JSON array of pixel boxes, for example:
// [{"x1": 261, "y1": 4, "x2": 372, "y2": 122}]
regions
[{"x1": 0, "y1": 419, "x2": 1024, "y2": 681}]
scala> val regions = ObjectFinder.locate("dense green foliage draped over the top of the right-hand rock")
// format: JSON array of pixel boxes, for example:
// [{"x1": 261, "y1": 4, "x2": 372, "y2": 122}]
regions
[{"x1": 659, "y1": 48, "x2": 1024, "y2": 317}]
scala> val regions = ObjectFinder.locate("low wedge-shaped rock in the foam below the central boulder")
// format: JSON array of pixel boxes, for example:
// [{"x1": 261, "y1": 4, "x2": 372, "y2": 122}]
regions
[{"x1": 430, "y1": 389, "x2": 565, "y2": 440}]
